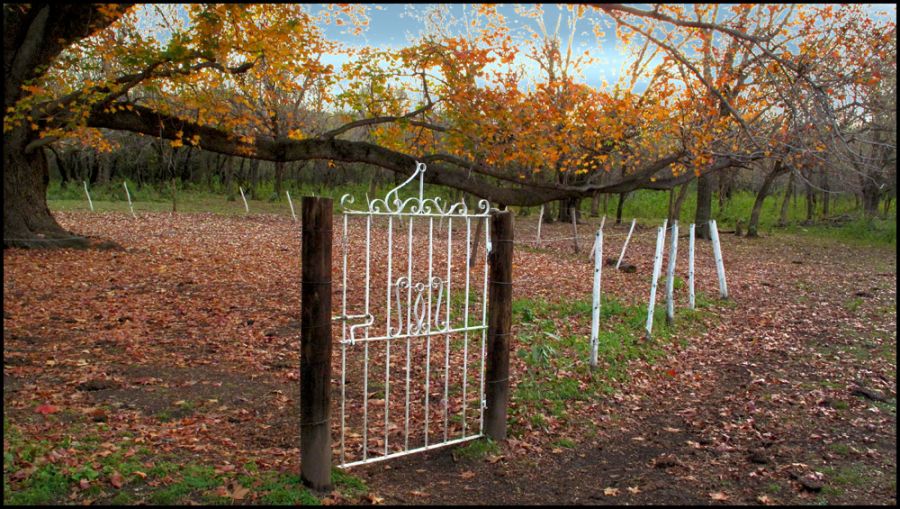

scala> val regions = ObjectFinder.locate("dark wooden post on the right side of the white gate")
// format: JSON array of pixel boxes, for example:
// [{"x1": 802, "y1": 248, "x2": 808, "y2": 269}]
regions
[{"x1": 484, "y1": 210, "x2": 513, "y2": 440}]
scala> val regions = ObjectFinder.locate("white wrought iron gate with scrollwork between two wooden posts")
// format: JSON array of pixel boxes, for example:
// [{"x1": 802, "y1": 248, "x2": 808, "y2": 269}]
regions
[{"x1": 334, "y1": 163, "x2": 491, "y2": 468}]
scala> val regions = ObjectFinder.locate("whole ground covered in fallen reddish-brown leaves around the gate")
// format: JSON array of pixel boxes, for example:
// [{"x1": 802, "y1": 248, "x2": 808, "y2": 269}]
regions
[{"x1": 3, "y1": 212, "x2": 896, "y2": 504}]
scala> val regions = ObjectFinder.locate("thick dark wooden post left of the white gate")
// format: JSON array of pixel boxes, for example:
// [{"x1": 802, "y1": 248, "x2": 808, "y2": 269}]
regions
[{"x1": 300, "y1": 196, "x2": 332, "y2": 490}]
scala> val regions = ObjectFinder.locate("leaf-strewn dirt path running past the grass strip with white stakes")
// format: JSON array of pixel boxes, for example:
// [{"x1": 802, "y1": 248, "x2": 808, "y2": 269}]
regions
[{"x1": 354, "y1": 234, "x2": 896, "y2": 504}]
